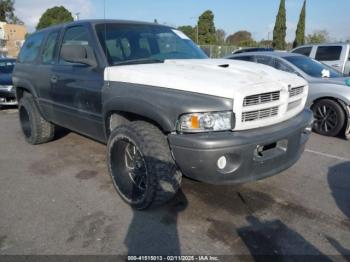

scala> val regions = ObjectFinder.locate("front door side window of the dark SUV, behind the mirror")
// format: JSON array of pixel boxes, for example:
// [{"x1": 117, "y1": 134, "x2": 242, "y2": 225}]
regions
[{"x1": 59, "y1": 26, "x2": 90, "y2": 65}]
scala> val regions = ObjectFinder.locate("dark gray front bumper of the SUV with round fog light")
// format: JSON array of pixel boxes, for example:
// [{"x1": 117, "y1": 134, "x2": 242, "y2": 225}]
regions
[{"x1": 168, "y1": 109, "x2": 313, "y2": 184}]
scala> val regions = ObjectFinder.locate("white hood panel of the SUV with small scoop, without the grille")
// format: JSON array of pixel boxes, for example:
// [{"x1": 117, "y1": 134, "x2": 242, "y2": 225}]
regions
[{"x1": 105, "y1": 59, "x2": 306, "y2": 98}]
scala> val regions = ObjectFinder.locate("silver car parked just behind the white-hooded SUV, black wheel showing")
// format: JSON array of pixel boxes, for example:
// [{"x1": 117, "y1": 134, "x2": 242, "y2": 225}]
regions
[{"x1": 227, "y1": 52, "x2": 350, "y2": 138}]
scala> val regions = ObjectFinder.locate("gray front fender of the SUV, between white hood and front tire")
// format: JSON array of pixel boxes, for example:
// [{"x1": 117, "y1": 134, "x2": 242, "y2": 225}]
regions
[{"x1": 102, "y1": 82, "x2": 233, "y2": 133}]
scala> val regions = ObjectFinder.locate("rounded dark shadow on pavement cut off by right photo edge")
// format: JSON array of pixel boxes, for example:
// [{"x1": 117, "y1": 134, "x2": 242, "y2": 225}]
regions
[{"x1": 328, "y1": 162, "x2": 350, "y2": 219}]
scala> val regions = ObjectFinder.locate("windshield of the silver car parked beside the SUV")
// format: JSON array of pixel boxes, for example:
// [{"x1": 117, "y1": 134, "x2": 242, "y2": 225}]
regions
[{"x1": 285, "y1": 56, "x2": 343, "y2": 78}]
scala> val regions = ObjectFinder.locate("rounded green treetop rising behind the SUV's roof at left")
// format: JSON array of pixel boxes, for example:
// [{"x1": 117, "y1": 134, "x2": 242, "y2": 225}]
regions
[{"x1": 36, "y1": 6, "x2": 74, "y2": 30}]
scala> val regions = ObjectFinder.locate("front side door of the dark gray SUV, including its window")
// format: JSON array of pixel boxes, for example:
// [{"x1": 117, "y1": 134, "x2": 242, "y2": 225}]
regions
[{"x1": 50, "y1": 25, "x2": 103, "y2": 140}]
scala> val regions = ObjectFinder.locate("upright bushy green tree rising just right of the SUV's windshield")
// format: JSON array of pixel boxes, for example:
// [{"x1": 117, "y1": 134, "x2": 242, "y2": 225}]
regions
[{"x1": 198, "y1": 10, "x2": 216, "y2": 45}]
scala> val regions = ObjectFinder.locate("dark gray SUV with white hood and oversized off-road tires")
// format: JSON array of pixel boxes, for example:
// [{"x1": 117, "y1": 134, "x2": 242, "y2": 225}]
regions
[{"x1": 13, "y1": 20, "x2": 312, "y2": 209}]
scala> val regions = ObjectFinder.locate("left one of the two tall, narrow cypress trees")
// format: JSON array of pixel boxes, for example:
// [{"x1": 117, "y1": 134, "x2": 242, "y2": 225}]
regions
[{"x1": 273, "y1": 0, "x2": 287, "y2": 50}]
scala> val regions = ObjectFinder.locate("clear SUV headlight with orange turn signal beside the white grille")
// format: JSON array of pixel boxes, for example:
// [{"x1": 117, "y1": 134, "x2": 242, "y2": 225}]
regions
[{"x1": 177, "y1": 111, "x2": 233, "y2": 133}]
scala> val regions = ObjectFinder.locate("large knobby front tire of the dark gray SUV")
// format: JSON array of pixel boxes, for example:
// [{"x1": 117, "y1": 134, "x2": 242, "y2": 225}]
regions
[{"x1": 107, "y1": 121, "x2": 182, "y2": 210}]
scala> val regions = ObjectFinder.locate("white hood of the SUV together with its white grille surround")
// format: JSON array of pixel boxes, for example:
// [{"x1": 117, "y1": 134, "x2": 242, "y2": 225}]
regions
[{"x1": 105, "y1": 59, "x2": 308, "y2": 130}]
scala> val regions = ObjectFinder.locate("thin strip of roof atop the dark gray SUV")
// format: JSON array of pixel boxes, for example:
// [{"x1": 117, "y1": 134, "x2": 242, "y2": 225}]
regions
[{"x1": 35, "y1": 19, "x2": 169, "y2": 33}]
